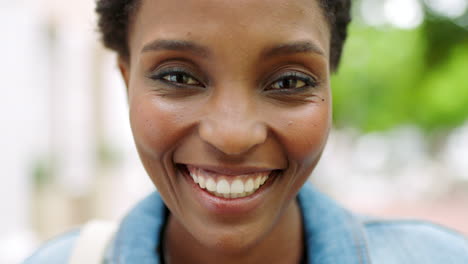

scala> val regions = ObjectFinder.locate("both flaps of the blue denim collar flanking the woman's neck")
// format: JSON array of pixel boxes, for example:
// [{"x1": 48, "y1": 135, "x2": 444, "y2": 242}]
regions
[{"x1": 108, "y1": 183, "x2": 371, "y2": 264}]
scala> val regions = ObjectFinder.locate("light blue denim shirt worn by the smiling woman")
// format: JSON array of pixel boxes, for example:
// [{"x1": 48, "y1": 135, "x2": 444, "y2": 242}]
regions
[{"x1": 24, "y1": 183, "x2": 468, "y2": 264}]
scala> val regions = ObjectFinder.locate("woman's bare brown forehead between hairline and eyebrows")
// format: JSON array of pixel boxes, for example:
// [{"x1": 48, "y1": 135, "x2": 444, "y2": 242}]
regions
[{"x1": 129, "y1": 0, "x2": 330, "y2": 60}]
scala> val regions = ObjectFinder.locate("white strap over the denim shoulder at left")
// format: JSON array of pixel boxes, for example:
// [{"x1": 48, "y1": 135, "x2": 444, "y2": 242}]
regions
[{"x1": 69, "y1": 221, "x2": 117, "y2": 264}]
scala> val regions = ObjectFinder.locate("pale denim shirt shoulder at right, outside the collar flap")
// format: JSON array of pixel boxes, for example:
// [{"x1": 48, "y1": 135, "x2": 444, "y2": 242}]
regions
[{"x1": 362, "y1": 219, "x2": 468, "y2": 264}]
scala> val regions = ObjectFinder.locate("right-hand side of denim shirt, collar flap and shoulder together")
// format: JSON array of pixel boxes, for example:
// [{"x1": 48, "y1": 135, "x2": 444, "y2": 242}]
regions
[{"x1": 298, "y1": 184, "x2": 468, "y2": 264}]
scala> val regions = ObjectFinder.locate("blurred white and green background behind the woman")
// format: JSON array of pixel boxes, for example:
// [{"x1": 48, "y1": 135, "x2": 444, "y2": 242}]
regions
[{"x1": 0, "y1": 0, "x2": 468, "y2": 264}]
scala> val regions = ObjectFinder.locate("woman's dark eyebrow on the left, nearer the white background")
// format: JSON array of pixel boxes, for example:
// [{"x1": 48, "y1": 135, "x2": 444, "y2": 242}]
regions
[{"x1": 141, "y1": 39, "x2": 210, "y2": 57}]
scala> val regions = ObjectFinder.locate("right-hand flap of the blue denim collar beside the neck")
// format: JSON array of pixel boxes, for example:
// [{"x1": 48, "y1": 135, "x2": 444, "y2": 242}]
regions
[{"x1": 298, "y1": 184, "x2": 371, "y2": 264}]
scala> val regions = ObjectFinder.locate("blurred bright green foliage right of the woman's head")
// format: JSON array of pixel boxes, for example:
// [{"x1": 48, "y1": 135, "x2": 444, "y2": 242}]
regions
[{"x1": 332, "y1": 13, "x2": 468, "y2": 132}]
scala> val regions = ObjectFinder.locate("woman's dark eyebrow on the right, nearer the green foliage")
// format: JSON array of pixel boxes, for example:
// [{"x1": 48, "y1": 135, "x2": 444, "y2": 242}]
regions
[{"x1": 262, "y1": 41, "x2": 325, "y2": 58}]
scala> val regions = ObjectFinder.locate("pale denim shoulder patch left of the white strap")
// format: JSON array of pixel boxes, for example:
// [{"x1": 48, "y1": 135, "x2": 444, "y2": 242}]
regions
[{"x1": 23, "y1": 229, "x2": 80, "y2": 264}]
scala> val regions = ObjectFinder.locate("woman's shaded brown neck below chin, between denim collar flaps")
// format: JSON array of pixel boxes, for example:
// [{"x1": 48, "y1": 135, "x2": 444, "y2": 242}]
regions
[{"x1": 164, "y1": 200, "x2": 304, "y2": 264}]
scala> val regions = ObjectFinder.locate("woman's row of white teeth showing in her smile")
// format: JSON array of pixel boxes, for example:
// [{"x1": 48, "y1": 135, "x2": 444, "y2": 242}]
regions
[{"x1": 188, "y1": 167, "x2": 269, "y2": 199}]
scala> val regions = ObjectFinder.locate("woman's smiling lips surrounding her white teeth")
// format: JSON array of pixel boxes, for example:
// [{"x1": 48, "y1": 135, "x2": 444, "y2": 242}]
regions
[{"x1": 181, "y1": 165, "x2": 277, "y2": 216}]
